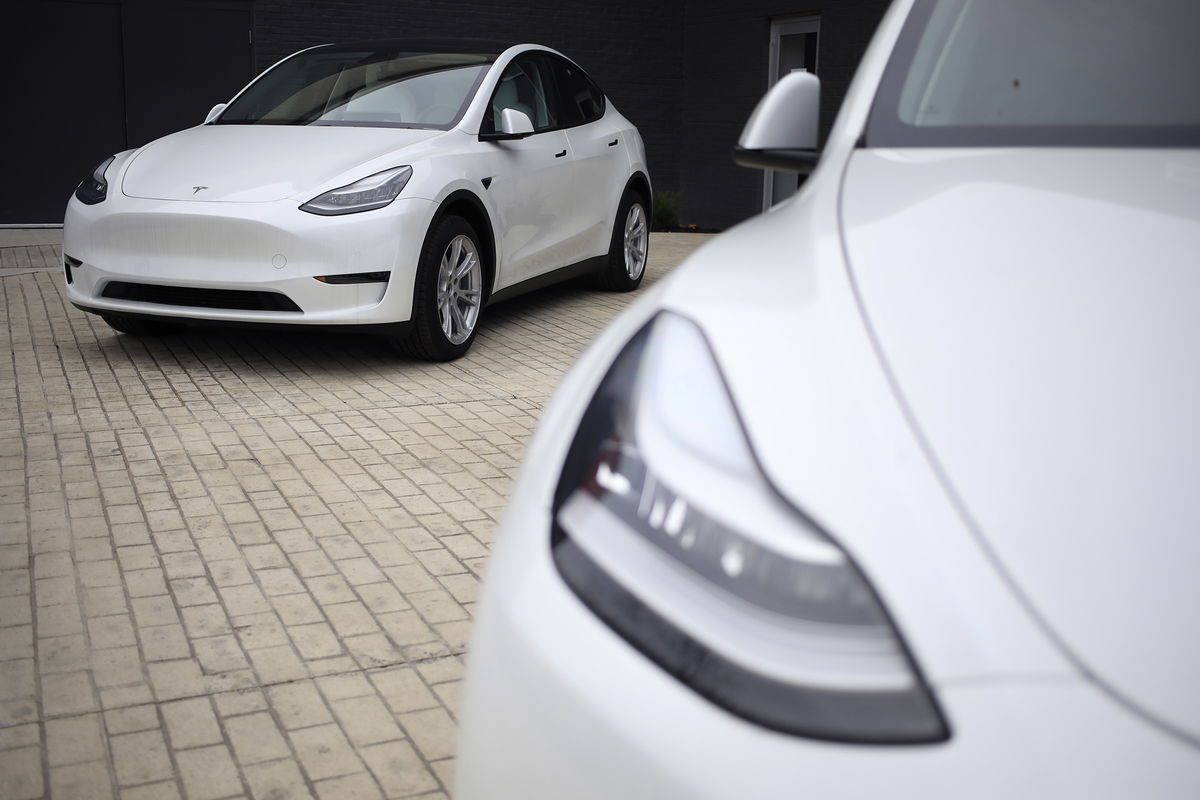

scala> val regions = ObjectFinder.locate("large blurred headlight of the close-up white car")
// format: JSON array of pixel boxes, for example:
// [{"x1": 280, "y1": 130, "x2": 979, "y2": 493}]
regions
[{"x1": 552, "y1": 313, "x2": 948, "y2": 744}]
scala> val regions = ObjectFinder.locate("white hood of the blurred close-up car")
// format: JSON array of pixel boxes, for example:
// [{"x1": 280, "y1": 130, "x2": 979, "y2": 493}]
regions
[{"x1": 841, "y1": 150, "x2": 1200, "y2": 740}]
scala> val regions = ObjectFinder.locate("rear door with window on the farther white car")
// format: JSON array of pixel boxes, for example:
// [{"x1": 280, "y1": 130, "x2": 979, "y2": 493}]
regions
[{"x1": 546, "y1": 54, "x2": 629, "y2": 259}]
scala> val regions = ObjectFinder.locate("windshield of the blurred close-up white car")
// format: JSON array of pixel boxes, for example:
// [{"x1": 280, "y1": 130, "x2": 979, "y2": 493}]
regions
[{"x1": 868, "y1": 0, "x2": 1200, "y2": 146}]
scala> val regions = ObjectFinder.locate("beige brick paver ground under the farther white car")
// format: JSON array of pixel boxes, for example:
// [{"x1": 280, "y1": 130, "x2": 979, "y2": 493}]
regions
[{"x1": 0, "y1": 231, "x2": 704, "y2": 800}]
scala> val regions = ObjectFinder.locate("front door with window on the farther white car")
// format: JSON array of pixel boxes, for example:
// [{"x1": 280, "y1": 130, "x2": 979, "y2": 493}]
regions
[{"x1": 484, "y1": 53, "x2": 577, "y2": 289}]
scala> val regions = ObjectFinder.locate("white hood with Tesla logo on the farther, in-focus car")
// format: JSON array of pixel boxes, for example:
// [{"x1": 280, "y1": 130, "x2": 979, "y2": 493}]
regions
[{"x1": 121, "y1": 125, "x2": 443, "y2": 203}]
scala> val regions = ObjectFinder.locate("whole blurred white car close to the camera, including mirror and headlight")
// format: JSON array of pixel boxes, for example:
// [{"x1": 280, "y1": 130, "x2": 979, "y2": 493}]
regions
[{"x1": 457, "y1": 0, "x2": 1200, "y2": 800}]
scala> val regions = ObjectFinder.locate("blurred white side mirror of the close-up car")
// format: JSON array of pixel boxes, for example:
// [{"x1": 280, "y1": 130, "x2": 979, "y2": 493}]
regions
[{"x1": 733, "y1": 72, "x2": 821, "y2": 173}]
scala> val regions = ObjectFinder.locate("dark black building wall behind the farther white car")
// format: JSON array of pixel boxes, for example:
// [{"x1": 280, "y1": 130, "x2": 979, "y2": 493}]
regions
[{"x1": 7, "y1": 0, "x2": 888, "y2": 229}]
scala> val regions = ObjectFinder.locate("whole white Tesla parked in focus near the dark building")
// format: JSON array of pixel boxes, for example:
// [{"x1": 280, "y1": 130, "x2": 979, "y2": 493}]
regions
[{"x1": 62, "y1": 42, "x2": 652, "y2": 360}]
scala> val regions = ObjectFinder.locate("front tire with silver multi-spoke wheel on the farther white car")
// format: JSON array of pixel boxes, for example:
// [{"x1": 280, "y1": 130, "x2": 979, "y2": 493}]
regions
[{"x1": 402, "y1": 216, "x2": 486, "y2": 361}]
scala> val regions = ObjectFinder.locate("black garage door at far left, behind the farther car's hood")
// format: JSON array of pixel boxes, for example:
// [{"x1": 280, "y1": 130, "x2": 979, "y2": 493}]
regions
[{"x1": 0, "y1": 0, "x2": 254, "y2": 224}]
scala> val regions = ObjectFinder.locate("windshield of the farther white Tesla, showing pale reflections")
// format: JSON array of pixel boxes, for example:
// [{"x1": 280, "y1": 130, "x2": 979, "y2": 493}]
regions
[{"x1": 216, "y1": 48, "x2": 496, "y2": 130}]
